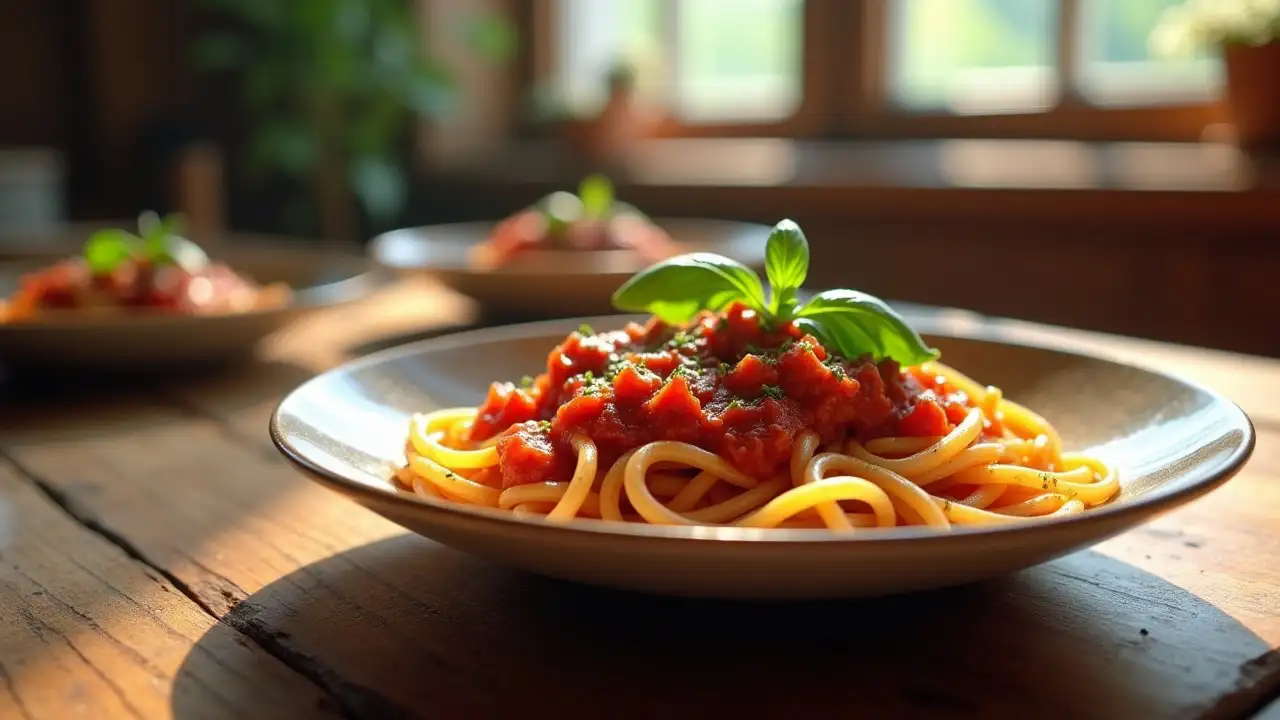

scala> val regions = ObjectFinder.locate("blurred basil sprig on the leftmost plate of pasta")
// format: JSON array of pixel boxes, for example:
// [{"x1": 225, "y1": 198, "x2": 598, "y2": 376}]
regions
[{"x1": 82, "y1": 210, "x2": 209, "y2": 274}]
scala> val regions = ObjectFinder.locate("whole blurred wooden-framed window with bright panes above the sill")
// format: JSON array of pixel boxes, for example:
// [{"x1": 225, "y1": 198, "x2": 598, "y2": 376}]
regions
[{"x1": 534, "y1": 0, "x2": 1221, "y2": 140}]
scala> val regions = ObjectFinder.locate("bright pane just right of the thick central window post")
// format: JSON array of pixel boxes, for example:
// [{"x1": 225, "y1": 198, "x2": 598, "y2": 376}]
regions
[{"x1": 888, "y1": 0, "x2": 1059, "y2": 114}]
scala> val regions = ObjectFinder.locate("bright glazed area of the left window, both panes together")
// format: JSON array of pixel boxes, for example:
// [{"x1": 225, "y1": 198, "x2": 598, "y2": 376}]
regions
[{"x1": 554, "y1": 0, "x2": 804, "y2": 123}]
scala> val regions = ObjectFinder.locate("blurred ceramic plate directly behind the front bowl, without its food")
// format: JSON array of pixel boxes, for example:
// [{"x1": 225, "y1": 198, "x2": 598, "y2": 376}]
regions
[{"x1": 369, "y1": 218, "x2": 771, "y2": 318}]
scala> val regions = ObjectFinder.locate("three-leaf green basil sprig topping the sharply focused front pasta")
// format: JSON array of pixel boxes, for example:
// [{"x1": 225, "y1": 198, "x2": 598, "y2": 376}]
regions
[{"x1": 613, "y1": 220, "x2": 938, "y2": 365}]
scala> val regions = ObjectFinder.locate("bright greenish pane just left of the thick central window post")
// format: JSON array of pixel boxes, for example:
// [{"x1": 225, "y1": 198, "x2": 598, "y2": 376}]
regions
[{"x1": 672, "y1": 0, "x2": 804, "y2": 122}]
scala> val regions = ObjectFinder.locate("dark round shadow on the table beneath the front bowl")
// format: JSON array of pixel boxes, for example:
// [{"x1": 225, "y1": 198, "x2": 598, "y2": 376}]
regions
[{"x1": 174, "y1": 536, "x2": 1268, "y2": 719}]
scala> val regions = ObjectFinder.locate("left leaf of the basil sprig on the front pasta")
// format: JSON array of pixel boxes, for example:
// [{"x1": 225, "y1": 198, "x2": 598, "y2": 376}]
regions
[{"x1": 613, "y1": 252, "x2": 764, "y2": 324}]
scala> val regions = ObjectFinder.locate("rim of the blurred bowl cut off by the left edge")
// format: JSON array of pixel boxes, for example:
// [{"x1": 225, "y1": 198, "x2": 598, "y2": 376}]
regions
[{"x1": 0, "y1": 243, "x2": 393, "y2": 333}]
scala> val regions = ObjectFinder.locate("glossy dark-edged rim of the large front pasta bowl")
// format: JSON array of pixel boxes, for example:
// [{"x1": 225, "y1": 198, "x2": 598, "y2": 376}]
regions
[{"x1": 268, "y1": 306, "x2": 1257, "y2": 547}]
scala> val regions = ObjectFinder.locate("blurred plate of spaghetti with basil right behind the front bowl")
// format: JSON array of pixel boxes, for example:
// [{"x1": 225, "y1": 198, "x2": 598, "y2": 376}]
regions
[{"x1": 369, "y1": 176, "x2": 768, "y2": 318}]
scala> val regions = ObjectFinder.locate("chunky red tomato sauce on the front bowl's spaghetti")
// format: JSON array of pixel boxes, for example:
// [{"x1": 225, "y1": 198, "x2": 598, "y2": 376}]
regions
[{"x1": 471, "y1": 304, "x2": 977, "y2": 488}]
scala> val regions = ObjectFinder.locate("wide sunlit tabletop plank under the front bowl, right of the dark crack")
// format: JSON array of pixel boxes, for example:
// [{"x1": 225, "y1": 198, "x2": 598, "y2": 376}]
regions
[{"x1": 0, "y1": 386, "x2": 1280, "y2": 717}]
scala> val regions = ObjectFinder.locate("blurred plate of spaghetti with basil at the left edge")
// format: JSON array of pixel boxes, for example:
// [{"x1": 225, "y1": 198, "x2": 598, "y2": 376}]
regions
[{"x1": 0, "y1": 213, "x2": 379, "y2": 366}]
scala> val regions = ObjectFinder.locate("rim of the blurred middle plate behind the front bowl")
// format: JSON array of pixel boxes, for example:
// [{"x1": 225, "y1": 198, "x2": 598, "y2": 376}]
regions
[{"x1": 366, "y1": 215, "x2": 772, "y2": 272}]
